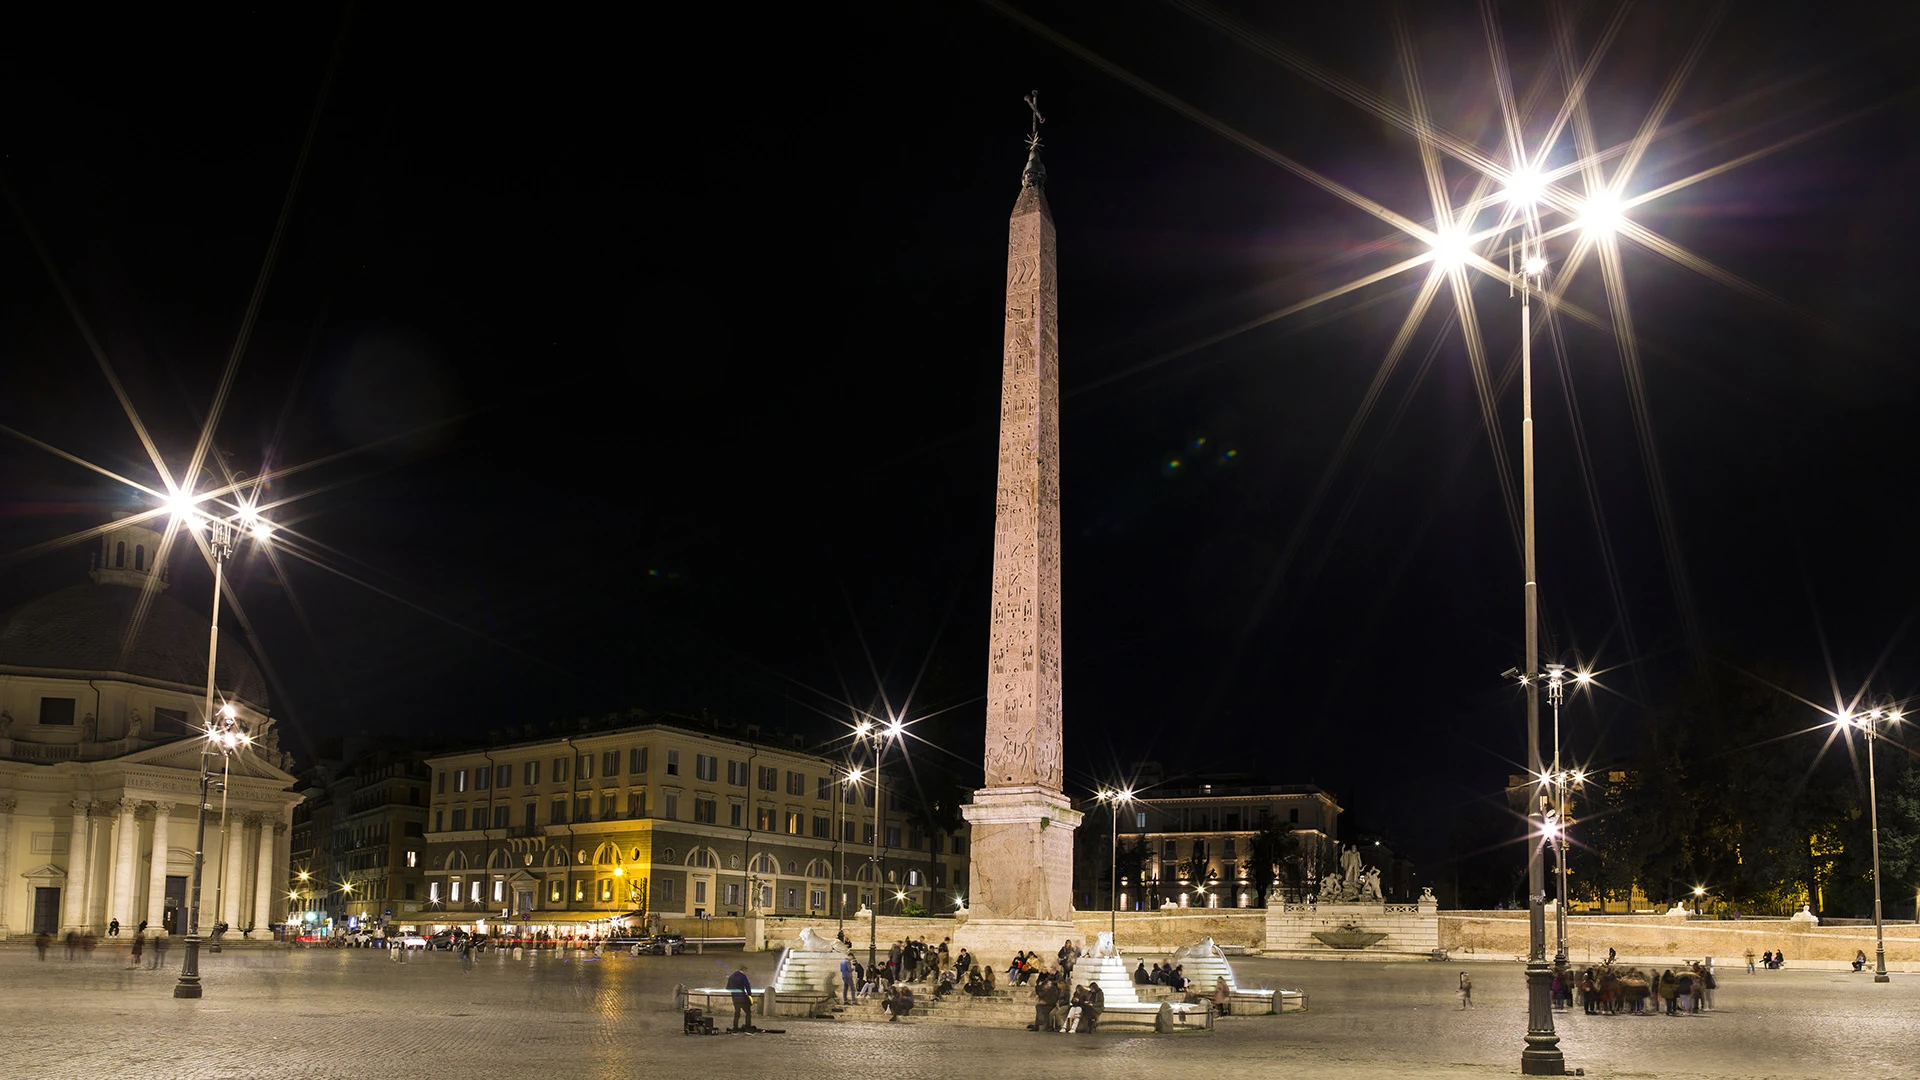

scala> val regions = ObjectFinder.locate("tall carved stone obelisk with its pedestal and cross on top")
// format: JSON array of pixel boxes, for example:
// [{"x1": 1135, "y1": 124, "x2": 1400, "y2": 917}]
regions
[{"x1": 954, "y1": 94, "x2": 1081, "y2": 949}]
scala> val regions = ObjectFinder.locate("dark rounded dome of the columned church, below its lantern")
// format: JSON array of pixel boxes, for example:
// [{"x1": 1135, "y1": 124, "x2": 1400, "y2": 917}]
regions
[{"x1": 0, "y1": 584, "x2": 267, "y2": 713}]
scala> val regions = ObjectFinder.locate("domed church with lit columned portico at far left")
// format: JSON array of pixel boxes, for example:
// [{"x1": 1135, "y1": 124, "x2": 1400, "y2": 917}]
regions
[{"x1": 0, "y1": 525, "x2": 300, "y2": 938}]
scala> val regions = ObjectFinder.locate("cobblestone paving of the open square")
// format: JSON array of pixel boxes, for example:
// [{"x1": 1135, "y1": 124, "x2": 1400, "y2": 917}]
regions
[{"x1": 0, "y1": 945, "x2": 1920, "y2": 1080}]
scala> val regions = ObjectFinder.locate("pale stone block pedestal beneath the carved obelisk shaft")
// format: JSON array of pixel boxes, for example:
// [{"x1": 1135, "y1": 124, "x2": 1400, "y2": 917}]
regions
[{"x1": 954, "y1": 786, "x2": 1081, "y2": 953}]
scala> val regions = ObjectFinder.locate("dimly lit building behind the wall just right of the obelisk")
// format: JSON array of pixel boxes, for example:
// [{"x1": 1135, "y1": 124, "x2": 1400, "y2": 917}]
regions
[{"x1": 1117, "y1": 767, "x2": 1340, "y2": 909}]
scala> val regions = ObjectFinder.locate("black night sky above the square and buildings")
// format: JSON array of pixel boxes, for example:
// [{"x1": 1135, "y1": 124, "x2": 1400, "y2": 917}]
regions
[{"x1": 0, "y1": 0, "x2": 1920, "y2": 865}]
